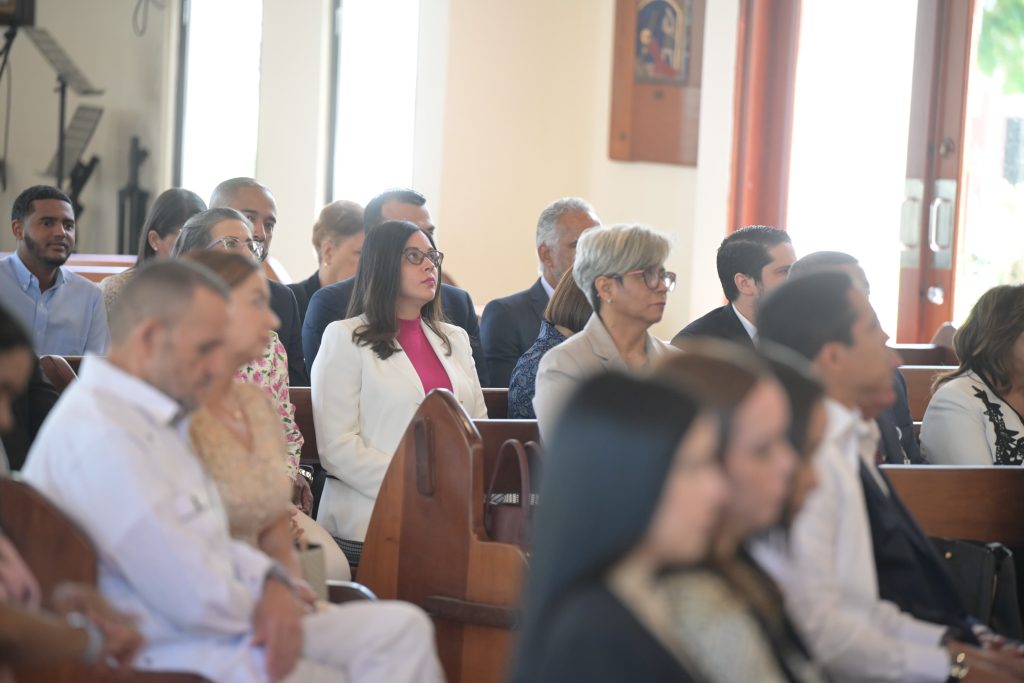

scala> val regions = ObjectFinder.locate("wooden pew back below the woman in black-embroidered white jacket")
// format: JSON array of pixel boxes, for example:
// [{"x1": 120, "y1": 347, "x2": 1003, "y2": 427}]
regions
[{"x1": 884, "y1": 465, "x2": 1024, "y2": 544}]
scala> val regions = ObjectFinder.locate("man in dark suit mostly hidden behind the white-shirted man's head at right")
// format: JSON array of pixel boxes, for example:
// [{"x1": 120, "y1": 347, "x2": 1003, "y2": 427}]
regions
[{"x1": 790, "y1": 251, "x2": 928, "y2": 465}]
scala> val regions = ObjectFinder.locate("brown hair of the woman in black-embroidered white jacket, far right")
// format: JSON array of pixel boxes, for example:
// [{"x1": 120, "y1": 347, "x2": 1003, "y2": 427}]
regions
[{"x1": 935, "y1": 285, "x2": 1024, "y2": 394}]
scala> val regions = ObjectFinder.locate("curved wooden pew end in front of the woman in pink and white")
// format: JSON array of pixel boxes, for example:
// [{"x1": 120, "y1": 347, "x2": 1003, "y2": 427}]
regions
[{"x1": 358, "y1": 391, "x2": 536, "y2": 683}]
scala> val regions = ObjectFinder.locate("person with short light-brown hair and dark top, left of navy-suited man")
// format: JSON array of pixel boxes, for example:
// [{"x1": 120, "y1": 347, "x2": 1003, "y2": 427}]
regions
[{"x1": 288, "y1": 200, "x2": 366, "y2": 325}]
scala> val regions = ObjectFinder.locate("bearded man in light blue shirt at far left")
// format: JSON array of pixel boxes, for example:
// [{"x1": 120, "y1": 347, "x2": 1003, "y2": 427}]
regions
[{"x1": 0, "y1": 185, "x2": 111, "y2": 355}]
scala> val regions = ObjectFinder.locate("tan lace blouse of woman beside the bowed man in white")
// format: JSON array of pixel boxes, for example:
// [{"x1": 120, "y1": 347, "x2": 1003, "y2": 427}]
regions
[{"x1": 188, "y1": 384, "x2": 292, "y2": 546}]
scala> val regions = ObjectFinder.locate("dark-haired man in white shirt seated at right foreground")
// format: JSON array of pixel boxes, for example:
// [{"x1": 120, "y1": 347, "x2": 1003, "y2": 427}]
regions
[{"x1": 754, "y1": 271, "x2": 1019, "y2": 682}]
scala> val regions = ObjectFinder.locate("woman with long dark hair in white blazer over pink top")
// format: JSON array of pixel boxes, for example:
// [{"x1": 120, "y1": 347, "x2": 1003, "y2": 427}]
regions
[{"x1": 310, "y1": 221, "x2": 487, "y2": 566}]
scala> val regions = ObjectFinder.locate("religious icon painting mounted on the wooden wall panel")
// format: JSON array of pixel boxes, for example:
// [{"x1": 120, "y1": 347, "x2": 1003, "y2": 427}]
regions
[{"x1": 633, "y1": 0, "x2": 693, "y2": 85}]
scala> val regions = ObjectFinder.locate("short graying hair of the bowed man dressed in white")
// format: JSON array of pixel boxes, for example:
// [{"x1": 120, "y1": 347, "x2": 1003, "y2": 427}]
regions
[{"x1": 110, "y1": 259, "x2": 229, "y2": 344}]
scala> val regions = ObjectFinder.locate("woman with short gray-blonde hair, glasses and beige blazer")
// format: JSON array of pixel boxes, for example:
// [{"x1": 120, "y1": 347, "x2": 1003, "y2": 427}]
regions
[{"x1": 534, "y1": 225, "x2": 676, "y2": 436}]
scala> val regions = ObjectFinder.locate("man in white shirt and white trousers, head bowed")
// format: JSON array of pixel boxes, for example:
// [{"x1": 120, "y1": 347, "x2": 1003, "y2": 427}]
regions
[{"x1": 24, "y1": 261, "x2": 442, "y2": 683}]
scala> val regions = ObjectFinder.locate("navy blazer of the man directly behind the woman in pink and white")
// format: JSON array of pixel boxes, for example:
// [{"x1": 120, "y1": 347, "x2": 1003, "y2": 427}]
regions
[{"x1": 302, "y1": 278, "x2": 490, "y2": 387}]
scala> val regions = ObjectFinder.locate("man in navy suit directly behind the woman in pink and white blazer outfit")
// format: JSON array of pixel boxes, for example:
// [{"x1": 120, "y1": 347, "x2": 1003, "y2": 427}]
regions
[{"x1": 302, "y1": 188, "x2": 490, "y2": 387}]
